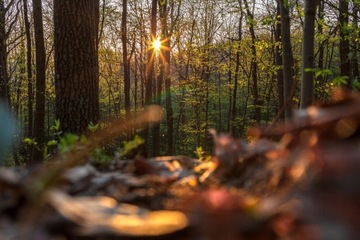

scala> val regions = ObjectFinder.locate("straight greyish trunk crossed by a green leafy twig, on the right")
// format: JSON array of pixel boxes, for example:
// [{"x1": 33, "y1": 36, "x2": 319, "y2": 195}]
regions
[{"x1": 300, "y1": 0, "x2": 317, "y2": 108}]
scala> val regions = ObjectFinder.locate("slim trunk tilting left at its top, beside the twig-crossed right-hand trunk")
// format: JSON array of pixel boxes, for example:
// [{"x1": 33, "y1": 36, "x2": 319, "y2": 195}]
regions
[{"x1": 277, "y1": 0, "x2": 295, "y2": 121}]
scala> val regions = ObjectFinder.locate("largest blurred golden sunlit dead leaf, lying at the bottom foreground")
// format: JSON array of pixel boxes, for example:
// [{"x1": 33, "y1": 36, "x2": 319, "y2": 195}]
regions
[{"x1": 48, "y1": 191, "x2": 188, "y2": 236}]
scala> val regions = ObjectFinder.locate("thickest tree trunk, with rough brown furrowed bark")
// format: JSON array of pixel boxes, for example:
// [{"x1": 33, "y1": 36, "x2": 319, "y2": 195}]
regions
[{"x1": 54, "y1": 0, "x2": 100, "y2": 134}]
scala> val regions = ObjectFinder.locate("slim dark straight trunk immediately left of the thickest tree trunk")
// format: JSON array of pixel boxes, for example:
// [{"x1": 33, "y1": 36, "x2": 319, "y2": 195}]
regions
[{"x1": 30, "y1": 0, "x2": 46, "y2": 164}]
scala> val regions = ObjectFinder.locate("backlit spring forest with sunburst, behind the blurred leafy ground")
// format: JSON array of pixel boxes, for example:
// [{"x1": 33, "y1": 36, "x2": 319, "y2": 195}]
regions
[{"x1": 0, "y1": 0, "x2": 360, "y2": 165}]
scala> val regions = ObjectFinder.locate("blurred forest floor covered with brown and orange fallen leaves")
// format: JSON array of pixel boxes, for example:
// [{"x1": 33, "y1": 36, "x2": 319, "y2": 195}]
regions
[{"x1": 0, "y1": 90, "x2": 360, "y2": 240}]
